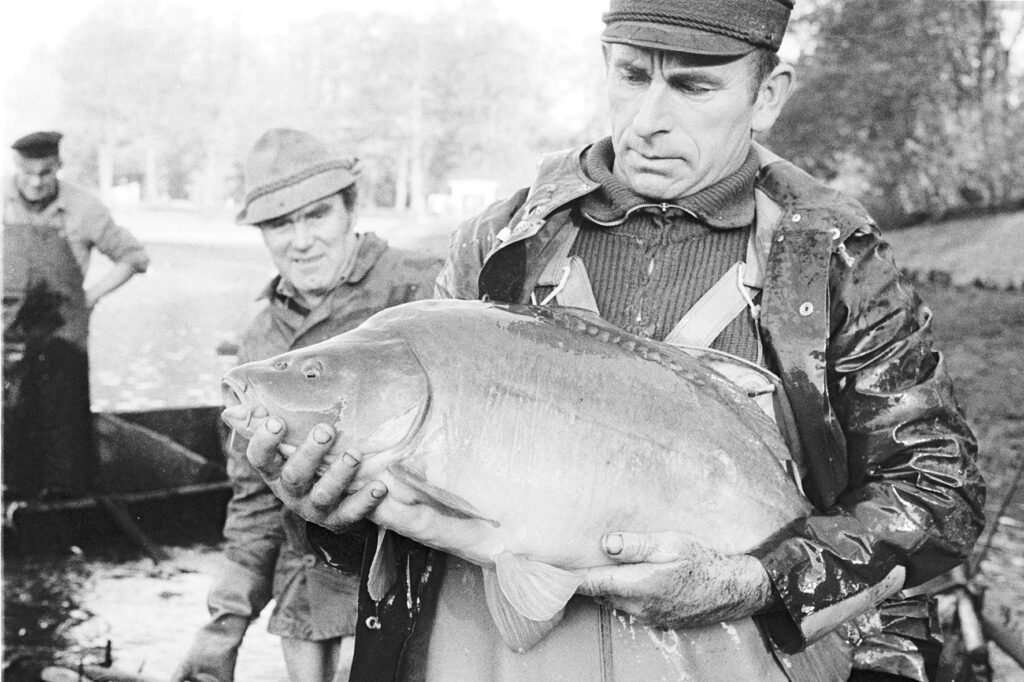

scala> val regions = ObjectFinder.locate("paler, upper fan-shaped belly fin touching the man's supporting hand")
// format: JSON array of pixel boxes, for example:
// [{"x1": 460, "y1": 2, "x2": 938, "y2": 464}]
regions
[{"x1": 495, "y1": 552, "x2": 583, "y2": 621}]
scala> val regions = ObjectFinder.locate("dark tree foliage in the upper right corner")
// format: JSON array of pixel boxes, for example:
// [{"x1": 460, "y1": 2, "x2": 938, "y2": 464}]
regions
[{"x1": 770, "y1": 0, "x2": 1024, "y2": 223}]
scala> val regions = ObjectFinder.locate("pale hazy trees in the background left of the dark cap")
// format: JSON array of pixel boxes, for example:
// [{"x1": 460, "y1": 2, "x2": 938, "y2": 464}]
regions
[{"x1": 6, "y1": 0, "x2": 599, "y2": 209}]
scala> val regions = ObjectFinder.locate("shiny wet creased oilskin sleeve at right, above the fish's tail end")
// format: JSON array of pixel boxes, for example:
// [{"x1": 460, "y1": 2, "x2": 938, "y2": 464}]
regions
[{"x1": 759, "y1": 229, "x2": 985, "y2": 649}]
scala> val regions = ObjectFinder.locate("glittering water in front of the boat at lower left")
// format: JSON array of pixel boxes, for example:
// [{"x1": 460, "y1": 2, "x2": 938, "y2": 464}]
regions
[{"x1": 3, "y1": 545, "x2": 288, "y2": 682}]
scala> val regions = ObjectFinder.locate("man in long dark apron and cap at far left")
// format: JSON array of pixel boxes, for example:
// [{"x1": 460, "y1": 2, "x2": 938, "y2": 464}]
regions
[{"x1": 3, "y1": 131, "x2": 150, "y2": 501}]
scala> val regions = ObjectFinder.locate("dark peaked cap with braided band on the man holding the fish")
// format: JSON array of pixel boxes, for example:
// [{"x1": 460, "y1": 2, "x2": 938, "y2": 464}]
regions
[{"x1": 601, "y1": 0, "x2": 794, "y2": 56}]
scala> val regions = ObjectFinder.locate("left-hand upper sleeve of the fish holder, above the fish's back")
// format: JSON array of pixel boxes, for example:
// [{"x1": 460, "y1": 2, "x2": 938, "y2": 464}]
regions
[{"x1": 434, "y1": 189, "x2": 527, "y2": 300}]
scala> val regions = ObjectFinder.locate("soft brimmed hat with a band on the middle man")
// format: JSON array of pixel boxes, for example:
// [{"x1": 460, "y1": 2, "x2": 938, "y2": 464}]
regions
[{"x1": 236, "y1": 128, "x2": 359, "y2": 225}]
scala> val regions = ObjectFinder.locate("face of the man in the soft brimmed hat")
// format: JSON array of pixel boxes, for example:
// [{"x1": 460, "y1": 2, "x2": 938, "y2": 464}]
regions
[{"x1": 259, "y1": 194, "x2": 357, "y2": 307}]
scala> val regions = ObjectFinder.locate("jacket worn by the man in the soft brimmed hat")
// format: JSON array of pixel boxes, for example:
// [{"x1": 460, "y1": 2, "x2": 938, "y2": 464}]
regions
[{"x1": 208, "y1": 233, "x2": 441, "y2": 640}]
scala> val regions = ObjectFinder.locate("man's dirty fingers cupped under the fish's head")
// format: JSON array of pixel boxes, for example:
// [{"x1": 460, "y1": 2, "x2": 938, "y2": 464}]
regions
[{"x1": 246, "y1": 417, "x2": 387, "y2": 532}]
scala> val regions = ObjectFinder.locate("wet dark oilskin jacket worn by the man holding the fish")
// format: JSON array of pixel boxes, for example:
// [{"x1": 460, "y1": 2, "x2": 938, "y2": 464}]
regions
[{"x1": 331, "y1": 142, "x2": 984, "y2": 679}]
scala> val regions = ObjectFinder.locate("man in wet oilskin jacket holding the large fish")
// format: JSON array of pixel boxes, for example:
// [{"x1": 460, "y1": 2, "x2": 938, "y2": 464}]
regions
[{"x1": 237, "y1": 0, "x2": 984, "y2": 682}]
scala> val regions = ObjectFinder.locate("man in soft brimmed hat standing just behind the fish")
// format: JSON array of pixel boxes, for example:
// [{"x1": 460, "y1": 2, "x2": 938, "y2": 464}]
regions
[{"x1": 173, "y1": 129, "x2": 441, "y2": 682}]
